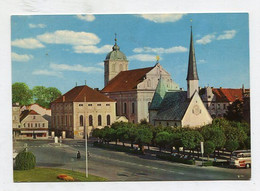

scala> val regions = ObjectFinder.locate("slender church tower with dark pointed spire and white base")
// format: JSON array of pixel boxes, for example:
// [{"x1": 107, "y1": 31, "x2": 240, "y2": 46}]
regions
[{"x1": 186, "y1": 26, "x2": 199, "y2": 99}]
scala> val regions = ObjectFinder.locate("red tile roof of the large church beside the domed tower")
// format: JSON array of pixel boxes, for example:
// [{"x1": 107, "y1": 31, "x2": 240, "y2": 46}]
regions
[{"x1": 101, "y1": 67, "x2": 154, "y2": 93}]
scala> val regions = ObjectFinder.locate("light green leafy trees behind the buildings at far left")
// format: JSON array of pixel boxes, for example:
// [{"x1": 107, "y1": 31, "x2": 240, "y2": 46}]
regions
[{"x1": 12, "y1": 82, "x2": 61, "y2": 108}]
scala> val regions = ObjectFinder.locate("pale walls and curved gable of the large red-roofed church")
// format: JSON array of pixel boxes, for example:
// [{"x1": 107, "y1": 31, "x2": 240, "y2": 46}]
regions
[{"x1": 102, "y1": 63, "x2": 179, "y2": 123}]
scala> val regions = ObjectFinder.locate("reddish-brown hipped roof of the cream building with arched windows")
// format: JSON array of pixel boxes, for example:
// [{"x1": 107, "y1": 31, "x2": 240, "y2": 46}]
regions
[{"x1": 52, "y1": 86, "x2": 115, "y2": 103}]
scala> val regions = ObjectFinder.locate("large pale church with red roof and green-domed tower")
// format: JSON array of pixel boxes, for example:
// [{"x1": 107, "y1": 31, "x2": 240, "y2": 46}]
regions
[{"x1": 101, "y1": 38, "x2": 180, "y2": 123}]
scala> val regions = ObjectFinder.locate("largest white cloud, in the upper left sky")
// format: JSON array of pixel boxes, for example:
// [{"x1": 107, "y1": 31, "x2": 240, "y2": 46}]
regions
[{"x1": 37, "y1": 30, "x2": 100, "y2": 45}]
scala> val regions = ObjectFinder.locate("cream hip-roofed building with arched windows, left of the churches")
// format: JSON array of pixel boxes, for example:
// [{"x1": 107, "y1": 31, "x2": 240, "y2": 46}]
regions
[{"x1": 51, "y1": 85, "x2": 116, "y2": 139}]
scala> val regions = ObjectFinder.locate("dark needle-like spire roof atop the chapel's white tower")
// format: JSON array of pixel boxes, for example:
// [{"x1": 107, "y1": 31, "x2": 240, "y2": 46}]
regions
[{"x1": 186, "y1": 20, "x2": 199, "y2": 80}]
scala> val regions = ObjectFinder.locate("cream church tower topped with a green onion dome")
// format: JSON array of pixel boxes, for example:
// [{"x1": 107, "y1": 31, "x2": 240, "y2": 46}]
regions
[{"x1": 104, "y1": 34, "x2": 128, "y2": 86}]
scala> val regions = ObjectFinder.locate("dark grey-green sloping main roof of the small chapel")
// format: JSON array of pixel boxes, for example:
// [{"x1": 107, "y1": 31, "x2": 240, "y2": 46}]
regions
[{"x1": 156, "y1": 91, "x2": 190, "y2": 121}]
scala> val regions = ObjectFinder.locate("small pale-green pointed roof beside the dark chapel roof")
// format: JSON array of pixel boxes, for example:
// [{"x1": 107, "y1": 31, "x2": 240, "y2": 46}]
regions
[{"x1": 149, "y1": 78, "x2": 167, "y2": 110}]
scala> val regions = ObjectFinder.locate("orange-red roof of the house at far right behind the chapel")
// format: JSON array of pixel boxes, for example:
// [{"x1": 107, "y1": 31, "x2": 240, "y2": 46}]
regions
[{"x1": 212, "y1": 88, "x2": 243, "y2": 102}]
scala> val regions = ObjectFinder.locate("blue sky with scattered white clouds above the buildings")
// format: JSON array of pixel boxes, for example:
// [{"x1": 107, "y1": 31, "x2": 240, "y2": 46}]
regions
[{"x1": 11, "y1": 13, "x2": 250, "y2": 93}]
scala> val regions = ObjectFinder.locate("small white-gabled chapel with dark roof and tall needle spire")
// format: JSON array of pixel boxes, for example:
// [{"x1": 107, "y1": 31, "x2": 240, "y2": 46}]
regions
[{"x1": 149, "y1": 29, "x2": 212, "y2": 128}]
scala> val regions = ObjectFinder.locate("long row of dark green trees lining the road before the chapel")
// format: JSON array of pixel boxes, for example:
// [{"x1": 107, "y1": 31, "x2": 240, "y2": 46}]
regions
[{"x1": 92, "y1": 119, "x2": 250, "y2": 159}]
